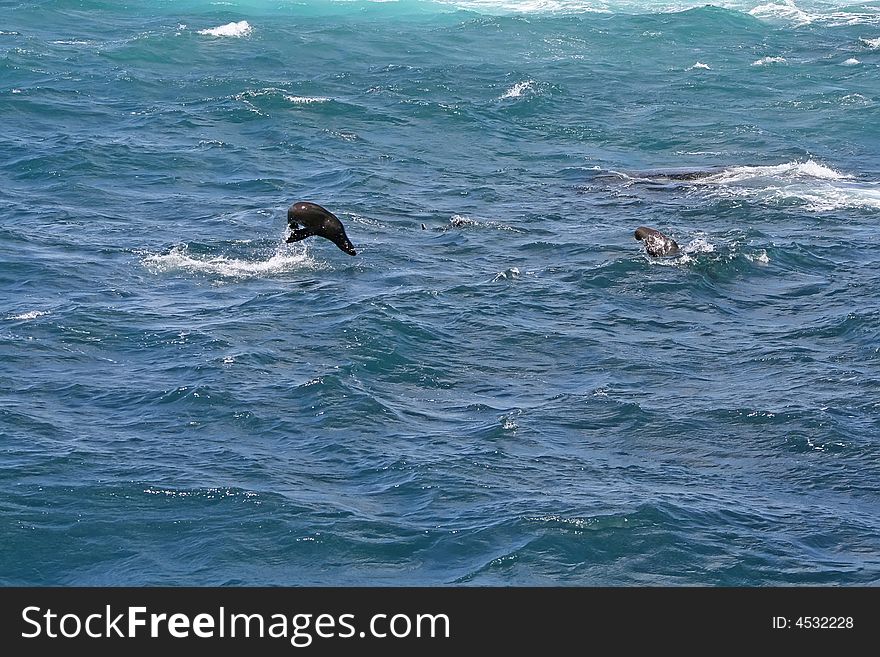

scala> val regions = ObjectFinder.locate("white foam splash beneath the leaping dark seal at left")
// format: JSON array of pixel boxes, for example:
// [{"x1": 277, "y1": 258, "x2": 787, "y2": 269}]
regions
[{"x1": 143, "y1": 245, "x2": 320, "y2": 278}]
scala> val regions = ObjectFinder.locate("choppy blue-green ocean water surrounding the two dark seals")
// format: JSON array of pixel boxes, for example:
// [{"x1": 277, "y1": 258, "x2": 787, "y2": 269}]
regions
[{"x1": 0, "y1": 0, "x2": 880, "y2": 586}]
